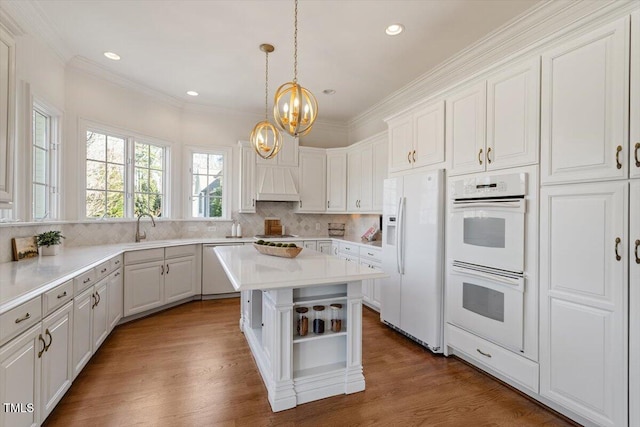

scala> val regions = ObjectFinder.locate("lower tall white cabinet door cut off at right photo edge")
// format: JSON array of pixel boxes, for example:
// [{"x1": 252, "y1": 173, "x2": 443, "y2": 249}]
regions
[{"x1": 629, "y1": 180, "x2": 640, "y2": 426}]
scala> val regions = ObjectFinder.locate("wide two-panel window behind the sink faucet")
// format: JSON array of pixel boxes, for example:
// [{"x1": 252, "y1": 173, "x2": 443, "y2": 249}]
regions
[{"x1": 85, "y1": 129, "x2": 168, "y2": 218}]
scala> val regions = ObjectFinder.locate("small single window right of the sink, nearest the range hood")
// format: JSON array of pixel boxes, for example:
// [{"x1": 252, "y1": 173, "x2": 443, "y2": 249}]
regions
[{"x1": 189, "y1": 150, "x2": 229, "y2": 218}]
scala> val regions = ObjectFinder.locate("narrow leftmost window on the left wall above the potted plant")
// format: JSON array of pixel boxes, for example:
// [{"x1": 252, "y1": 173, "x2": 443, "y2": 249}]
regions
[{"x1": 31, "y1": 103, "x2": 58, "y2": 220}]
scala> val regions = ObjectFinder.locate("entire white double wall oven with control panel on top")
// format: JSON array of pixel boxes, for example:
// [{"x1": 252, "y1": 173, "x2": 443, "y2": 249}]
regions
[{"x1": 447, "y1": 172, "x2": 527, "y2": 351}]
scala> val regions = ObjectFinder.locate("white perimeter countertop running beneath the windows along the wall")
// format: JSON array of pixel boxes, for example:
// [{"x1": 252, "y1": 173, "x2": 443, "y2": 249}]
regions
[{"x1": 0, "y1": 236, "x2": 379, "y2": 314}]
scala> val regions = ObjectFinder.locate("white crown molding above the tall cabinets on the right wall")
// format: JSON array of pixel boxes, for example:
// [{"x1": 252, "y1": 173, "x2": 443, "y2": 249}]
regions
[{"x1": 347, "y1": 0, "x2": 637, "y2": 133}]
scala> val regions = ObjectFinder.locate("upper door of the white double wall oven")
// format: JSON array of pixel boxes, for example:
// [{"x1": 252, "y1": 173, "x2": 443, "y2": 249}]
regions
[{"x1": 449, "y1": 199, "x2": 526, "y2": 272}]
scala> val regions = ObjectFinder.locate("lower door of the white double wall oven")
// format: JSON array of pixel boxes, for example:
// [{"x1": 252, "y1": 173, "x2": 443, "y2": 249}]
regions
[{"x1": 447, "y1": 266, "x2": 524, "y2": 351}]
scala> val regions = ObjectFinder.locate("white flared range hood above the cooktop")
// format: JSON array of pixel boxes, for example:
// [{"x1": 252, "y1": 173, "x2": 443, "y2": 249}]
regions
[{"x1": 256, "y1": 165, "x2": 300, "y2": 202}]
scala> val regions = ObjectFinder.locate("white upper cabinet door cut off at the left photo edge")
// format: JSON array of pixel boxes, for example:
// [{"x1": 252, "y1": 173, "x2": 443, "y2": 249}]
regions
[{"x1": 0, "y1": 28, "x2": 16, "y2": 207}]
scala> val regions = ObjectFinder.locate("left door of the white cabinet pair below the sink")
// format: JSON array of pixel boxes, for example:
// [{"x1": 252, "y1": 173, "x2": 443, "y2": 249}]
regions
[{"x1": 124, "y1": 261, "x2": 165, "y2": 317}]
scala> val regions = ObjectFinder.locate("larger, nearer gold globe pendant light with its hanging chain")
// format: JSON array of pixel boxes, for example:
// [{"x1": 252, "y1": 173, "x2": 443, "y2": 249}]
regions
[{"x1": 273, "y1": 0, "x2": 318, "y2": 137}]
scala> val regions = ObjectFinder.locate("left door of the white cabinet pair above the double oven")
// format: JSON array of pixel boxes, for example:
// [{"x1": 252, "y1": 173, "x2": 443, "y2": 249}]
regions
[{"x1": 446, "y1": 82, "x2": 487, "y2": 175}]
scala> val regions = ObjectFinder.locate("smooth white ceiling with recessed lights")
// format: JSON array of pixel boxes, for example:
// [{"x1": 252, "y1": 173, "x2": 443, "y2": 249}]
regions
[{"x1": 11, "y1": 0, "x2": 539, "y2": 123}]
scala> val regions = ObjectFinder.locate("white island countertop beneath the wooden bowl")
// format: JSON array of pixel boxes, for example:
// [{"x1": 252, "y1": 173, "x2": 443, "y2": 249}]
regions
[{"x1": 214, "y1": 245, "x2": 387, "y2": 291}]
